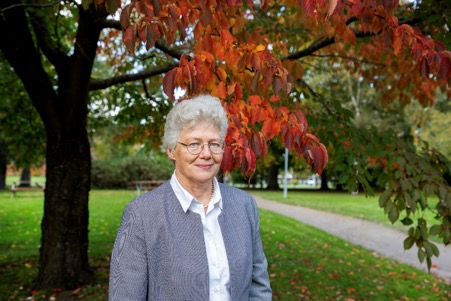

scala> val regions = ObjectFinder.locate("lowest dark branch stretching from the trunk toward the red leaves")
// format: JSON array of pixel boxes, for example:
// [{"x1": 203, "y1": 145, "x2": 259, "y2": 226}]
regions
[{"x1": 89, "y1": 63, "x2": 179, "y2": 91}]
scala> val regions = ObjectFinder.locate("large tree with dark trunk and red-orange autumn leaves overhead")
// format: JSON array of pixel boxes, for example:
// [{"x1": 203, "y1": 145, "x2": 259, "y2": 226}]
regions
[{"x1": 0, "y1": 0, "x2": 451, "y2": 288}]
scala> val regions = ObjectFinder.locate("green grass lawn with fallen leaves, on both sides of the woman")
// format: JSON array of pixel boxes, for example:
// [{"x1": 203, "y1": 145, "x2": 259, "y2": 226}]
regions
[{"x1": 0, "y1": 190, "x2": 451, "y2": 301}]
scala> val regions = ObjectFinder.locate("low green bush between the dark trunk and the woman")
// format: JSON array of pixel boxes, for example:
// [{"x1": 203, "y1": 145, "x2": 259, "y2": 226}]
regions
[{"x1": 91, "y1": 153, "x2": 174, "y2": 188}]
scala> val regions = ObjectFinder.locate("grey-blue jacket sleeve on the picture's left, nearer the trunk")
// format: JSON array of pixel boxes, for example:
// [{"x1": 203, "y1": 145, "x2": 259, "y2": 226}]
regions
[{"x1": 108, "y1": 202, "x2": 149, "y2": 301}]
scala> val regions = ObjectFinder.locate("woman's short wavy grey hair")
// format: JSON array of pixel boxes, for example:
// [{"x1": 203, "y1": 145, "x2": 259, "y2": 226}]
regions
[{"x1": 163, "y1": 95, "x2": 228, "y2": 149}]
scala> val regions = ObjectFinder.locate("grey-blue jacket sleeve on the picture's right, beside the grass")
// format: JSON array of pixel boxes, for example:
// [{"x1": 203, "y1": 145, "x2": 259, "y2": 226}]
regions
[{"x1": 249, "y1": 198, "x2": 272, "y2": 301}]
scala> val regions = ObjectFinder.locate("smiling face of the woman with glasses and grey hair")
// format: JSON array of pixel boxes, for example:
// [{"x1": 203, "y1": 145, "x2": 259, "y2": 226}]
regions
[{"x1": 168, "y1": 122, "x2": 223, "y2": 189}]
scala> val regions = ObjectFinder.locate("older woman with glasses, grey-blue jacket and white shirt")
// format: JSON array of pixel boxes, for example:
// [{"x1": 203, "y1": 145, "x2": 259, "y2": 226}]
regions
[{"x1": 109, "y1": 95, "x2": 272, "y2": 301}]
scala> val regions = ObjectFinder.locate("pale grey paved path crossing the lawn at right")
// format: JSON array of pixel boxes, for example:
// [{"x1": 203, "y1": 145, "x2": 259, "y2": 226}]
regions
[{"x1": 254, "y1": 196, "x2": 451, "y2": 283}]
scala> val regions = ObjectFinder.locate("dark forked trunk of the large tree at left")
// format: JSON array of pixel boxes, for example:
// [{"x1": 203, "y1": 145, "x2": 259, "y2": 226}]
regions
[{"x1": 0, "y1": 0, "x2": 102, "y2": 289}]
